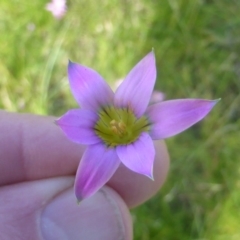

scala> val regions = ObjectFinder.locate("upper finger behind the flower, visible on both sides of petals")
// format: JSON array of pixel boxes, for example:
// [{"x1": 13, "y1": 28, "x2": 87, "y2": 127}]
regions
[{"x1": 0, "y1": 112, "x2": 169, "y2": 207}]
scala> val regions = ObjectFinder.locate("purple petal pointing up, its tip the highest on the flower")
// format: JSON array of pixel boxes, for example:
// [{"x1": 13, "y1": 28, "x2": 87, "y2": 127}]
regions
[{"x1": 114, "y1": 52, "x2": 156, "y2": 117}]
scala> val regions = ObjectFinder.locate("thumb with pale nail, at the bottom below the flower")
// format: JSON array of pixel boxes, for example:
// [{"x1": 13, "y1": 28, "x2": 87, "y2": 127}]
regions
[{"x1": 0, "y1": 177, "x2": 132, "y2": 240}]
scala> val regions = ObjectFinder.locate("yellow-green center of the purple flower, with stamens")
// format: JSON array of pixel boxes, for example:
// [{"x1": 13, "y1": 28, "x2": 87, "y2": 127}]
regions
[{"x1": 94, "y1": 106, "x2": 150, "y2": 147}]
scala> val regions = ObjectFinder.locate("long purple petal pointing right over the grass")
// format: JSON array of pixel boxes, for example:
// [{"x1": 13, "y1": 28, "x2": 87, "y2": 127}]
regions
[{"x1": 146, "y1": 99, "x2": 218, "y2": 139}]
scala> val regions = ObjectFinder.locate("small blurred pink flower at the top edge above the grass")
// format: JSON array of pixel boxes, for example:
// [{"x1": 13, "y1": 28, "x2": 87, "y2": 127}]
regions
[{"x1": 46, "y1": 0, "x2": 67, "y2": 19}]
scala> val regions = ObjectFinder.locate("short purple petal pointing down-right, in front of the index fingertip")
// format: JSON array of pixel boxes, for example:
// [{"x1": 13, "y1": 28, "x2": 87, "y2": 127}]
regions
[{"x1": 117, "y1": 132, "x2": 155, "y2": 179}]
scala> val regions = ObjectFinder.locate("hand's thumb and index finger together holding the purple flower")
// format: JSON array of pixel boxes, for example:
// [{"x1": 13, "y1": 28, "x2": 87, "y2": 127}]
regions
[{"x1": 0, "y1": 111, "x2": 169, "y2": 240}]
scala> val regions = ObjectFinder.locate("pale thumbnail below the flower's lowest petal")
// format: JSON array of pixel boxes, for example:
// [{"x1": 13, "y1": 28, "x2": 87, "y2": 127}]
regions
[{"x1": 41, "y1": 188, "x2": 126, "y2": 240}]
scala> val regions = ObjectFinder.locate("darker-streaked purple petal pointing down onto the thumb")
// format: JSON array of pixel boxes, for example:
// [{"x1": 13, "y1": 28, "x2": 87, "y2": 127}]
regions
[{"x1": 75, "y1": 143, "x2": 120, "y2": 201}]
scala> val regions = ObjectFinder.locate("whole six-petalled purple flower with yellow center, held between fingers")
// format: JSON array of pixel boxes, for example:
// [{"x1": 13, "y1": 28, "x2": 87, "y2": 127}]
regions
[{"x1": 56, "y1": 52, "x2": 218, "y2": 201}]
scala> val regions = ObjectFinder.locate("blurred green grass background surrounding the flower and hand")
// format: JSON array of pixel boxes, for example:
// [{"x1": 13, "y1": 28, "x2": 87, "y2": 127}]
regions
[{"x1": 0, "y1": 0, "x2": 240, "y2": 240}]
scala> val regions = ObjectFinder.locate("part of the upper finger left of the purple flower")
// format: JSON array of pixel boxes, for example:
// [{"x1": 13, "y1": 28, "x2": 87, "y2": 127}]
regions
[{"x1": 0, "y1": 111, "x2": 84, "y2": 186}]
